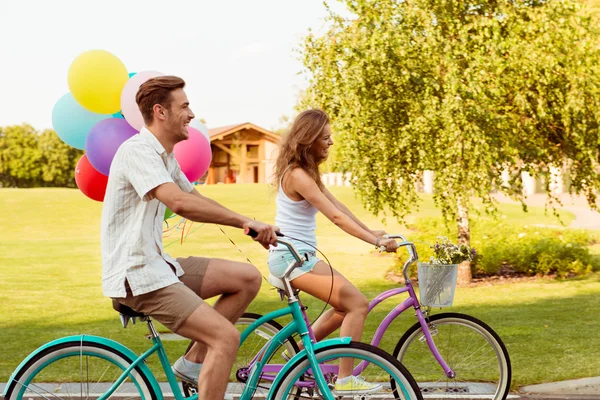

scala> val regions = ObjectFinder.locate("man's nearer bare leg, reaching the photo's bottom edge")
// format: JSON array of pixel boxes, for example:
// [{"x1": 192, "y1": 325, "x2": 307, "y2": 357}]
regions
[{"x1": 176, "y1": 303, "x2": 240, "y2": 400}]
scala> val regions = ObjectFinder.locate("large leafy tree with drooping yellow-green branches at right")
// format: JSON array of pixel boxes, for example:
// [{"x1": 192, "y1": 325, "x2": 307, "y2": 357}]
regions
[{"x1": 302, "y1": 0, "x2": 600, "y2": 282}]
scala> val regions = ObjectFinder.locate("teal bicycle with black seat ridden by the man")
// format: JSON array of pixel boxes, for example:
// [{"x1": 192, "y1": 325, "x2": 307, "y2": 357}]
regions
[{"x1": 4, "y1": 231, "x2": 422, "y2": 400}]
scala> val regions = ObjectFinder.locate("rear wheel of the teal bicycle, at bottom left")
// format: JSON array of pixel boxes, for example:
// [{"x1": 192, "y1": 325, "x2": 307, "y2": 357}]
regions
[{"x1": 6, "y1": 340, "x2": 158, "y2": 400}]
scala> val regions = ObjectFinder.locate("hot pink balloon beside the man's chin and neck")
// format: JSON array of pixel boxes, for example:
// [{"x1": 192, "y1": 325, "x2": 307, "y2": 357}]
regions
[{"x1": 173, "y1": 126, "x2": 212, "y2": 182}]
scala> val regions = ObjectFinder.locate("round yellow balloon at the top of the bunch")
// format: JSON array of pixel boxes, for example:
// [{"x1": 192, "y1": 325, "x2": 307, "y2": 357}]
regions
[{"x1": 69, "y1": 50, "x2": 129, "y2": 114}]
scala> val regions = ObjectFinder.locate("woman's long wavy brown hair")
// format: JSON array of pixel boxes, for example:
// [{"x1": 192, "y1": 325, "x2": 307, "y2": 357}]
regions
[{"x1": 273, "y1": 109, "x2": 329, "y2": 189}]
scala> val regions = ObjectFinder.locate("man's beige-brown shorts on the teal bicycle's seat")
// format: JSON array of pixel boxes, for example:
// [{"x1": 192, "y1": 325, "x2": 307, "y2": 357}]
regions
[{"x1": 115, "y1": 257, "x2": 210, "y2": 332}]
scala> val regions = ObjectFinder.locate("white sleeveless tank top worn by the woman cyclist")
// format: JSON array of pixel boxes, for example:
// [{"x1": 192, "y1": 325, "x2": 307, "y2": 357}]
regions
[{"x1": 272, "y1": 170, "x2": 319, "y2": 251}]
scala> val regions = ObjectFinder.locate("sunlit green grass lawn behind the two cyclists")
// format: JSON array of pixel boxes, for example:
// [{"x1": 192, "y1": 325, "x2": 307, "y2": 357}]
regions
[{"x1": 0, "y1": 185, "x2": 600, "y2": 386}]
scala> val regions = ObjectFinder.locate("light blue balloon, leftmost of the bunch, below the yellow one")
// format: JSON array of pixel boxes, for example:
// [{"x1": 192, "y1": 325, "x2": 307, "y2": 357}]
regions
[{"x1": 52, "y1": 93, "x2": 110, "y2": 150}]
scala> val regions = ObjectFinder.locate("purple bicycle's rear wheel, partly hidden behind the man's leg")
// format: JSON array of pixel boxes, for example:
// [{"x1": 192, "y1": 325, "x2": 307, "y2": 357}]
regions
[{"x1": 182, "y1": 313, "x2": 299, "y2": 396}]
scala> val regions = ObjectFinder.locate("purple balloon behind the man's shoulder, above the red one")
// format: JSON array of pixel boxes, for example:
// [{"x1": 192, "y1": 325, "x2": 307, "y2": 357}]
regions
[{"x1": 85, "y1": 118, "x2": 138, "y2": 175}]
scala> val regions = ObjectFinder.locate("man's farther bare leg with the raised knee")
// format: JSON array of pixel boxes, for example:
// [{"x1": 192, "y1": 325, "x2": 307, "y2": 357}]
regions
[{"x1": 180, "y1": 258, "x2": 262, "y2": 369}]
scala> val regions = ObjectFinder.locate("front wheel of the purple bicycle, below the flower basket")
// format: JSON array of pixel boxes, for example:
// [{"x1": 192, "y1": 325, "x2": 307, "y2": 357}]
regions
[{"x1": 393, "y1": 313, "x2": 512, "y2": 400}]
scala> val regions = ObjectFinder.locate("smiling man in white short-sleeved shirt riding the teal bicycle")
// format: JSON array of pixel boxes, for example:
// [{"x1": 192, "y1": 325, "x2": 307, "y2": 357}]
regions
[{"x1": 102, "y1": 76, "x2": 276, "y2": 400}]
